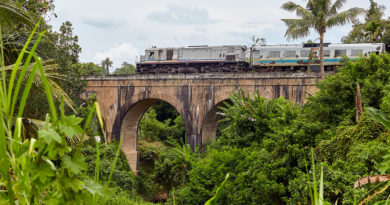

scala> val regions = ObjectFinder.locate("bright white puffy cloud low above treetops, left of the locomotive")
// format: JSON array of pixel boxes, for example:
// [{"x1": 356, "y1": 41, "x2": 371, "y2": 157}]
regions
[{"x1": 93, "y1": 43, "x2": 138, "y2": 68}]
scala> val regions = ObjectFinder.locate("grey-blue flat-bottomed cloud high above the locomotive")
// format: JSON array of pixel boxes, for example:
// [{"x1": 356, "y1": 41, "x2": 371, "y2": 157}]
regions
[{"x1": 147, "y1": 4, "x2": 217, "y2": 25}]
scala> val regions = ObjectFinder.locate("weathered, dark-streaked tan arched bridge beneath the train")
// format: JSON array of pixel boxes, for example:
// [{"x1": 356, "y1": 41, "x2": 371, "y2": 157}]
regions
[{"x1": 84, "y1": 73, "x2": 319, "y2": 172}]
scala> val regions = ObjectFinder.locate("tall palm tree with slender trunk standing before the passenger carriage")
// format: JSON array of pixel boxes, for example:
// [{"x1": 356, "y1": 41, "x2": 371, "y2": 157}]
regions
[{"x1": 282, "y1": 0, "x2": 364, "y2": 79}]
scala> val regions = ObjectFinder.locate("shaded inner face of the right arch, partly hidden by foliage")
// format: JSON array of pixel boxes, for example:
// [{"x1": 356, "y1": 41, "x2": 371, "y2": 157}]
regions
[{"x1": 200, "y1": 99, "x2": 232, "y2": 145}]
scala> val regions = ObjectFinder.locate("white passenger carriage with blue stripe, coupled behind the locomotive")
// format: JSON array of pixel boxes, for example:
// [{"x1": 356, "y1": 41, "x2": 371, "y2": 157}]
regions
[{"x1": 252, "y1": 43, "x2": 385, "y2": 71}]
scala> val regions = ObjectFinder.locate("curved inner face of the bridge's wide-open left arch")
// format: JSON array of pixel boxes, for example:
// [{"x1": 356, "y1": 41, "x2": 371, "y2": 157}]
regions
[{"x1": 116, "y1": 98, "x2": 188, "y2": 173}]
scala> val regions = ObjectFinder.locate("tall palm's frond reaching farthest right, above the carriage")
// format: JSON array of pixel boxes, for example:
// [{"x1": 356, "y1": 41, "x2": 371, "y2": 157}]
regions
[{"x1": 326, "y1": 7, "x2": 365, "y2": 28}]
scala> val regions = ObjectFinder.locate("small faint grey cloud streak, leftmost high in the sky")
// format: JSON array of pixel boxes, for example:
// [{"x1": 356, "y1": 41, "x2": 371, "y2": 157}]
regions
[{"x1": 81, "y1": 16, "x2": 126, "y2": 28}]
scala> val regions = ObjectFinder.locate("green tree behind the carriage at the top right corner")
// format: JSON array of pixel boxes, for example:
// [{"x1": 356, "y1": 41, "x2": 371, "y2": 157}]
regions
[{"x1": 342, "y1": 0, "x2": 390, "y2": 43}]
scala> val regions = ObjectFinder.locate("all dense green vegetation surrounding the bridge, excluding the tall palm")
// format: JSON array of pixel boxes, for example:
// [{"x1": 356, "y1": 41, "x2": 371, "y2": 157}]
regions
[{"x1": 0, "y1": 0, "x2": 390, "y2": 204}]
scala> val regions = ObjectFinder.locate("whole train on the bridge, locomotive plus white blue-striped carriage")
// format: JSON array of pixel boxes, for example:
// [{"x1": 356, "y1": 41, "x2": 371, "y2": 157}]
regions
[{"x1": 136, "y1": 43, "x2": 389, "y2": 74}]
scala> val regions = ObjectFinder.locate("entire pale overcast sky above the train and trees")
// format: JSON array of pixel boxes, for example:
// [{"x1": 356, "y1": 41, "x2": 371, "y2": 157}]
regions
[{"x1": 50, "y1": 0, "x2": 390, "y2": 67}]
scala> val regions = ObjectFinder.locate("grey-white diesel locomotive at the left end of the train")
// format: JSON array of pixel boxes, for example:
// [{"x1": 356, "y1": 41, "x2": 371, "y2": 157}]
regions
[{"x1": 137, "y1": 45, "x2": 248, "y2": 73}]
